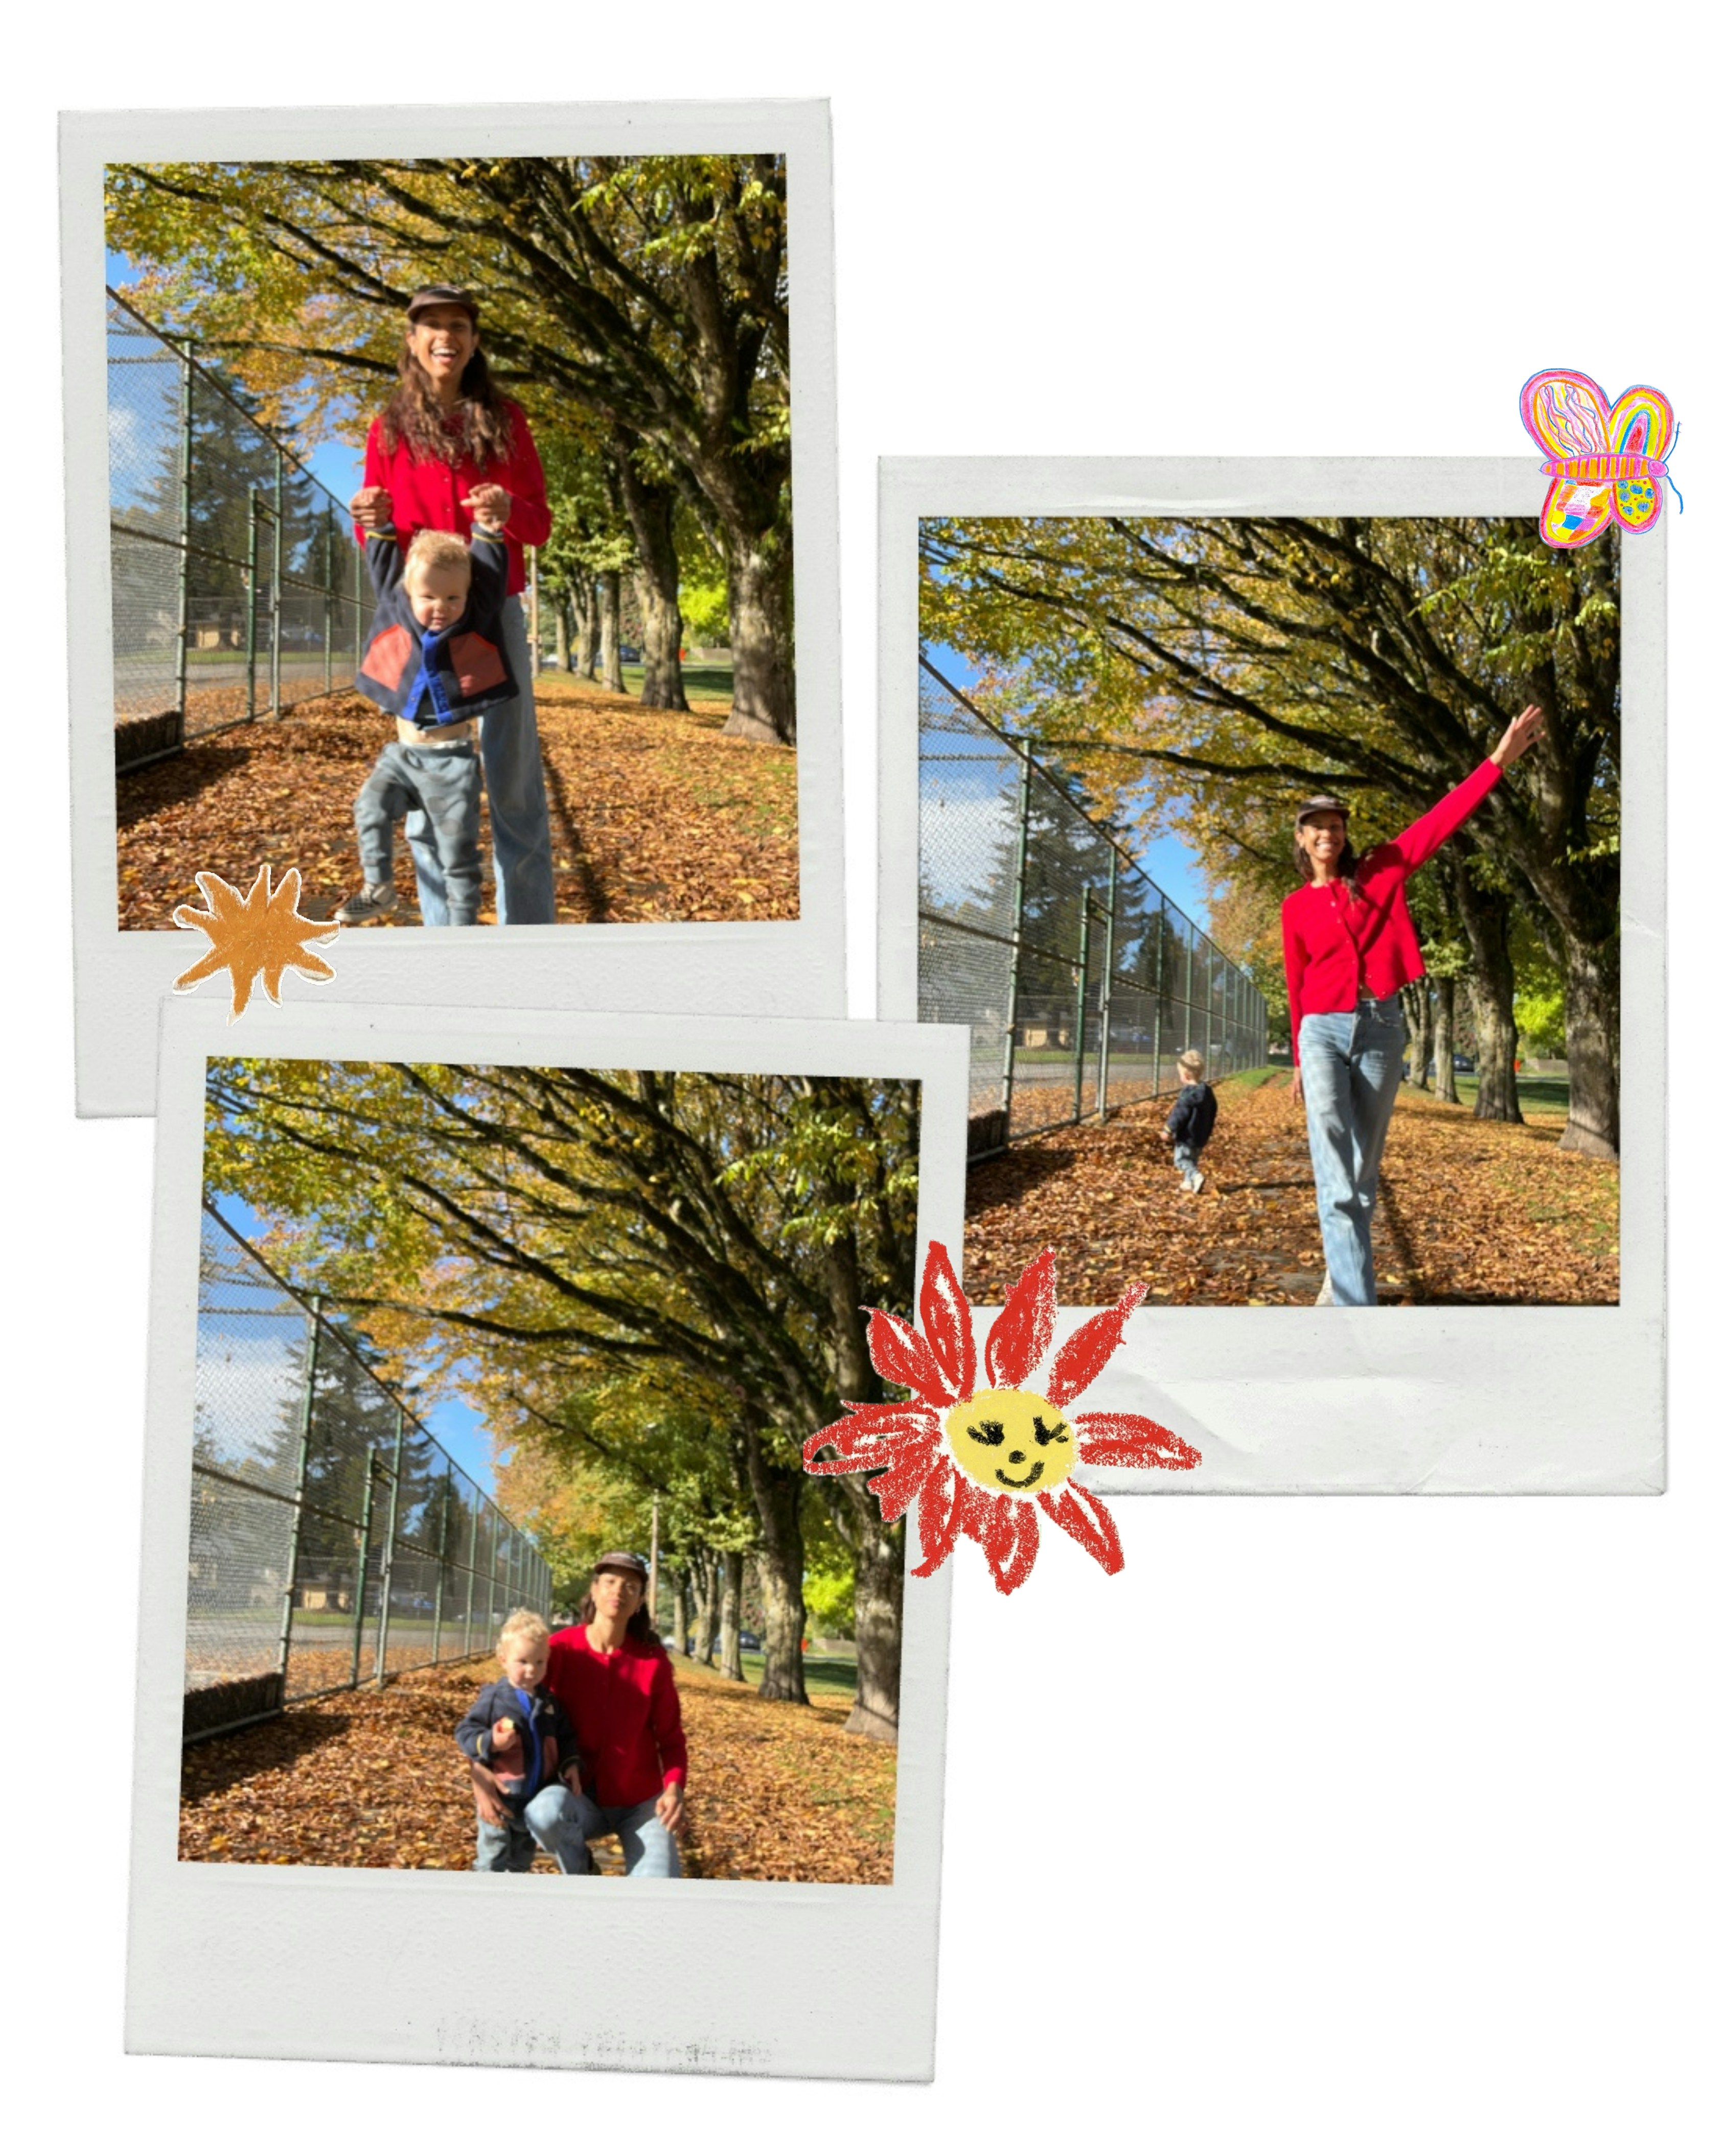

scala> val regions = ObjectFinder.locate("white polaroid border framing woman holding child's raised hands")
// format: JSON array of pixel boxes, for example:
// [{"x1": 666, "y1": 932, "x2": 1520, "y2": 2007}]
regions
[{"x1": 60, "y1": 99, "x2": 845, "y2": 1115}]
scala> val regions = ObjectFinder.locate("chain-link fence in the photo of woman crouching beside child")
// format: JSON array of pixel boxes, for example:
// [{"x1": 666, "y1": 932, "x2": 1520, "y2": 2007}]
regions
[{"x1": 186, "y1": 1208, "x2": 550, "y2": 1738}]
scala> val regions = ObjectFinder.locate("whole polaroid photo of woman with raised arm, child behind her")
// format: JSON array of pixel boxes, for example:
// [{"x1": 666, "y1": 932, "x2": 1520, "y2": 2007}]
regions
[{"x1": 878, "y1": 457, "x2": 1667, "y2": 1494}]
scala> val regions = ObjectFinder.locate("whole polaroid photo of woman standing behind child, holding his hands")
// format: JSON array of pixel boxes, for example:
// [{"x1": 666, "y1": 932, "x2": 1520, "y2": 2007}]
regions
[{"x1": 60, "y1": 101, "x2": 845, "y2": 1115}]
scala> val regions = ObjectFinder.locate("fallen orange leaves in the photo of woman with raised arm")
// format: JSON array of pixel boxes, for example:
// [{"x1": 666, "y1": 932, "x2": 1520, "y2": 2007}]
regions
[{"x1": 964, "y1": 1072, "x2": 1617, "y2": 1304}]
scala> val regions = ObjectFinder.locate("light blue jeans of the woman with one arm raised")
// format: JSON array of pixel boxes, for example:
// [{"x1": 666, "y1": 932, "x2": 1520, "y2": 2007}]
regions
[{"x1": 1300, "y1": 996, "x2": 1404, "y2": 1309}]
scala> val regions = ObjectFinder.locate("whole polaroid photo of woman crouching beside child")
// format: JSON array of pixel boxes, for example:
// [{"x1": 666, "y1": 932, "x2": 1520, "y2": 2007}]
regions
[{"x1": 127, "y1": 1003, "x2": 966, "y2": 2080}]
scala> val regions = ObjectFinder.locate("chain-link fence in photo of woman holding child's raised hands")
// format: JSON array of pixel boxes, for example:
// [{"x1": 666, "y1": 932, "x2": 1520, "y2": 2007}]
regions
[{"x1": 108, "y1": 291, "x2": 371, "y2": 770}]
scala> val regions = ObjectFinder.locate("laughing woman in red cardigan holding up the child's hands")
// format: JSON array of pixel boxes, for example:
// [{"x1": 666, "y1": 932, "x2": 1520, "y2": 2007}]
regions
[{"x1": 352, "y1": 285, "x2": 556, "y2": 927}]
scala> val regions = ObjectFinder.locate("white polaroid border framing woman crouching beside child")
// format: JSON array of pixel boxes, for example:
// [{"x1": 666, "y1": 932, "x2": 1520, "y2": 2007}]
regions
[{"x1": 127, "y1": 1003, "x2": 968, "y2": 2080}]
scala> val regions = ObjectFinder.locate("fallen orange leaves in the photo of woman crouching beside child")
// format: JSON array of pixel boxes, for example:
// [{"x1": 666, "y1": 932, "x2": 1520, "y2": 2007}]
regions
[{"x1": 179, "y1": 1656, "x2": 897, "y2": 1884}]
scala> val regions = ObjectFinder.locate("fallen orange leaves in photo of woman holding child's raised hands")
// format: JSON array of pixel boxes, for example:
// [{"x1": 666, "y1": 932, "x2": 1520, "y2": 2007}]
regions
[{"x1": 117, "y1": 675, "x2": 798, "y2": 929}]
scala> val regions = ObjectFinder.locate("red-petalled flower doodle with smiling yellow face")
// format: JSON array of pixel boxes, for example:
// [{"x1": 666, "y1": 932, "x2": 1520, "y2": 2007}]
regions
[{"x1": 802, "y1": 1242, "x2": 1199, "y2": 1595}]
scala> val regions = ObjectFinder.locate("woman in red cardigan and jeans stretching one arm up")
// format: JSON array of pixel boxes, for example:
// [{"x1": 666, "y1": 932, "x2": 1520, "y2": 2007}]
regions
[{"x1": 1281, "y1": 705, "x2": 1546, "y2": 1307}]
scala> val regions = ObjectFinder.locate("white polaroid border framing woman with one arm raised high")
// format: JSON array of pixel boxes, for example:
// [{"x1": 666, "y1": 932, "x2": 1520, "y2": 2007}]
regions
[{"x1": 878, "y1": 455, "x2": 1667, "y2": 1496}]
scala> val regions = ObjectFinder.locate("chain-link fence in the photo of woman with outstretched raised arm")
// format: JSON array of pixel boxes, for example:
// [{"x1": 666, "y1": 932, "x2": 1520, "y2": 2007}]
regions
[{"x1": 916, "y1": 660, "x2": 1263, "y2": 1153}]
